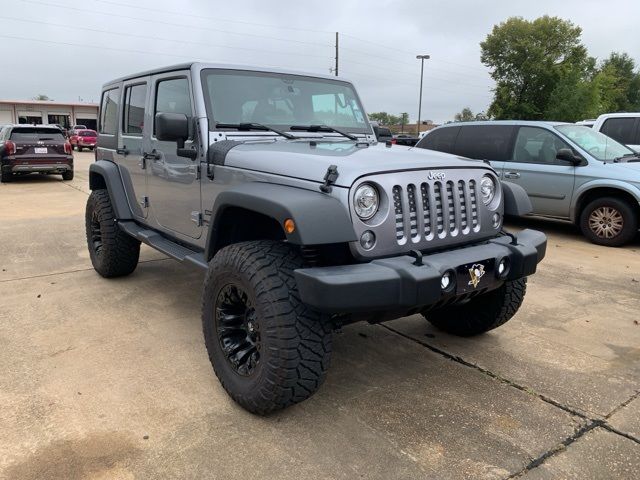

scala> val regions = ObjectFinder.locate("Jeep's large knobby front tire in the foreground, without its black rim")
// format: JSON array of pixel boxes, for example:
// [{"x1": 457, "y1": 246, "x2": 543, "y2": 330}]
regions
[{"x1": 202, "y1": 241, "x2": 333, "y2": 415}]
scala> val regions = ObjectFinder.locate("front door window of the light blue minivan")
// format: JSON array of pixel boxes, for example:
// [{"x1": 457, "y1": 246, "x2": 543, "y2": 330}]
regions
[{"x1": 513, "y1": 127, "x2": 571, "y2": 165}]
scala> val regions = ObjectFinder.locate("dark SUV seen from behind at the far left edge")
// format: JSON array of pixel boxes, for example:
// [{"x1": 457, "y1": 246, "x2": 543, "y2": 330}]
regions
[{"x1": 0, "y1": 125, "x2": 73, "y2": 183}]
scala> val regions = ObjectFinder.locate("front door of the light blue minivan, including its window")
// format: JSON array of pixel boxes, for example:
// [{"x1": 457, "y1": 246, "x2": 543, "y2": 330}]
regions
[{"x1": 502, "y1": 127, "x2": 576, "y2": 218}]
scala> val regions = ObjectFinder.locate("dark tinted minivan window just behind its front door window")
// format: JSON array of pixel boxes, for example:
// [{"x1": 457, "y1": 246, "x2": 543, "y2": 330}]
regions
[{"x1": 455, "y1": 125, "x2": 515, "y2": 161}]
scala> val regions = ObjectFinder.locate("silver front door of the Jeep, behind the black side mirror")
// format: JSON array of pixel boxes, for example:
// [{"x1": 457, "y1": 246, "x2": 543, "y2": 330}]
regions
[{"x1": 144, "y1": 71, "x2": 202, "y2": 238}]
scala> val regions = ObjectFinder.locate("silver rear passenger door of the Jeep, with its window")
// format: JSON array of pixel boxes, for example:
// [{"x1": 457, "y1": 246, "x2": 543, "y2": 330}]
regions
[{"x1": 116, "y1": 77, "x2": 150, "y2": 218}]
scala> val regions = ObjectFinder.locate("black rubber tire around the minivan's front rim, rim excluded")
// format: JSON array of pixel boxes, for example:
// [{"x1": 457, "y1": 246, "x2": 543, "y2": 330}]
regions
[{"x1": 580, "y1": 197, "x2": 638, "y2": 247}]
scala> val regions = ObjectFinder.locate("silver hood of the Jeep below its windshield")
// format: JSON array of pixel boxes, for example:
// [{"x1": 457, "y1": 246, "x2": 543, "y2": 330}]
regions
[{"x1": 216, "y1": 139, "x2": 490, "y2": 187}]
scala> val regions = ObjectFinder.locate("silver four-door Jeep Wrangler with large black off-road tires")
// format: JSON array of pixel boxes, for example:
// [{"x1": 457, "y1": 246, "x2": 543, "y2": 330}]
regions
[{"x1": 86, "y1": 63, "x2": 546, "y2": 414}]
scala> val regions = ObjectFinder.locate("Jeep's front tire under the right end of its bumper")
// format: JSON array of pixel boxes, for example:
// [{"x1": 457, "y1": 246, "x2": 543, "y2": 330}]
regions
[{"x1": 424, "y1": 278, "x2": 527, "y2": 337}]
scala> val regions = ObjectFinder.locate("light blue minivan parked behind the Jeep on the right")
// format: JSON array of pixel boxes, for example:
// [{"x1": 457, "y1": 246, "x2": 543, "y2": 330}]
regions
[{"x1": 417, "y1": 121, "x2": 640, "y2": 246}]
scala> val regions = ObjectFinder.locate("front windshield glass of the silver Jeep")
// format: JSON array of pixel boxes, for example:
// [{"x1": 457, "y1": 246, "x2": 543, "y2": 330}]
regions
[{"x1": 202, "y1": 70, "x2": 371, "y2": 133}]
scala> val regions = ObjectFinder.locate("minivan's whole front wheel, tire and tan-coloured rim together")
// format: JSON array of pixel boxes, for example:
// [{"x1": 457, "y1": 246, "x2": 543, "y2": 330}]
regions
[{"x1": 580, "y1": 197, "x2": 638, "y2": 247}]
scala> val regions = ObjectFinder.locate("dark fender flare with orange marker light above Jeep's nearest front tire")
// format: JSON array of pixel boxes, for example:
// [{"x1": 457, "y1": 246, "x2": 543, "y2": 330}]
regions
[{"x1": 205, "y1": 182, "x2": 357, "y2": 260}]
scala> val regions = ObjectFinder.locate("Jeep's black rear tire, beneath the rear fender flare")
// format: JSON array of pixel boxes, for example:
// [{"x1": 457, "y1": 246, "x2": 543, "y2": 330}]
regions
[{"x1": 85, "y1": 189, "x2": 140, "y2": 278}]
